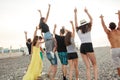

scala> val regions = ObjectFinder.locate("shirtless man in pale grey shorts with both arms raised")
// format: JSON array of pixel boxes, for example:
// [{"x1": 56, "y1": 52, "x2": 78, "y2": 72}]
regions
[{"x1": 100, "y1": 10, "x2": 120, "y2": 76}]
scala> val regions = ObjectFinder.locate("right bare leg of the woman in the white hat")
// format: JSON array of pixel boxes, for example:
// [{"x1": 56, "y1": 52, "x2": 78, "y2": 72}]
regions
[{"x1": 87, "y1": 53, "x2": 98, "y2": 80}]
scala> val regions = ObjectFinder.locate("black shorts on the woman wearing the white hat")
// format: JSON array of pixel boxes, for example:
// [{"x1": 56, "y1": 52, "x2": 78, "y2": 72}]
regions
[{"x1": 80, "y1": 43, "x2": 94, "y2": 54}]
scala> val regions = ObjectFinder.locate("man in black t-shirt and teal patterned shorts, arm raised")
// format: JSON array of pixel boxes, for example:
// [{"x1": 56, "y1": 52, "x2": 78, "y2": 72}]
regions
[{"x1": 53, "y1": 24, "x2": 68, "y2": 80}]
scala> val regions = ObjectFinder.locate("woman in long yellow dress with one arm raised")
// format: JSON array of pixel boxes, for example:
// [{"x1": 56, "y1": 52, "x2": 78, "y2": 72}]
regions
[{"x1": 22, "y1": 27, "x2": 43, "y2": 80}]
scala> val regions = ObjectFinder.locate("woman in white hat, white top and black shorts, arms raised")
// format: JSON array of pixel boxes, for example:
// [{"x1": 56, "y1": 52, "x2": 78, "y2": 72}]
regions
[{"x1": 74, "y1": 8, "x2": 98, "y2": 80}]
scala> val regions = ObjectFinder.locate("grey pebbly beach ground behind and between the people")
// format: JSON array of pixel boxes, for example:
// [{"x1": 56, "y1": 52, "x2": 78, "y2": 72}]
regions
[{"x1": 0, "y1": 47, "x2": 120, "y2": 80}]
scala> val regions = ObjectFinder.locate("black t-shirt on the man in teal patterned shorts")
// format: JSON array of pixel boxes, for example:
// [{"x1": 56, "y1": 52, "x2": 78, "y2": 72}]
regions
[{"x1": 55, "y1": 34, "x2": 67, "y2": 52}]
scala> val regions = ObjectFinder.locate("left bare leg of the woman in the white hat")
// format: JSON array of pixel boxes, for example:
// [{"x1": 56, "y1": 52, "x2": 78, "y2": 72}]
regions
[{"x1": 81, "y1": 54, "x2": 91, "y2": 80}]
